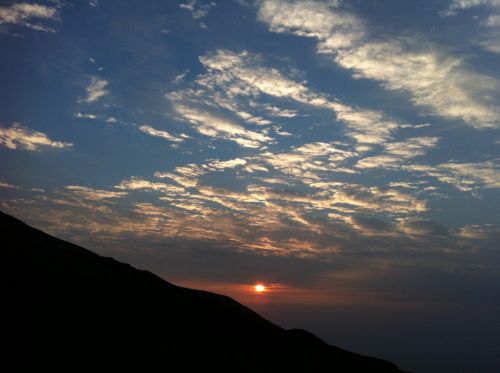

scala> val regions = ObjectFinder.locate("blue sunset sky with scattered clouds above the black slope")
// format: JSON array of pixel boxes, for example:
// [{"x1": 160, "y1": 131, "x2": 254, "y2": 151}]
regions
[{"x1": 0, "y1": 0, "x2": 500, "y2": 372}]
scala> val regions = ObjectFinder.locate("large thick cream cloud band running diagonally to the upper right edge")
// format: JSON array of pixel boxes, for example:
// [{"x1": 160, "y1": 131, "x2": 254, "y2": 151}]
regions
[{"x1": 258, "y1": 0, "x2": 500, "y2": 128}]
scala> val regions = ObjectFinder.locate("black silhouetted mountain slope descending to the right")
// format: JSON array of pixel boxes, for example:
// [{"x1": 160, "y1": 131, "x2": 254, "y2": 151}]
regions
[{"x1": 4, "y1": 212, "x2": 406, "y2": 372}]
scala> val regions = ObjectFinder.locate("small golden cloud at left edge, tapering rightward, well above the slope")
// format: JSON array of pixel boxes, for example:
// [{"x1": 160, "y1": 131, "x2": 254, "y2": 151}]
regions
[{"x1": 0, "y1": 122, "x2": 73, "y2": 151}]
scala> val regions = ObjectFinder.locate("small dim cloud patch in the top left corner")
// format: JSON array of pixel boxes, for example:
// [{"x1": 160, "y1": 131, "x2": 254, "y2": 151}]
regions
[{"x1": 0, "y1": 3, "x2": 60, "y2": 32}]
